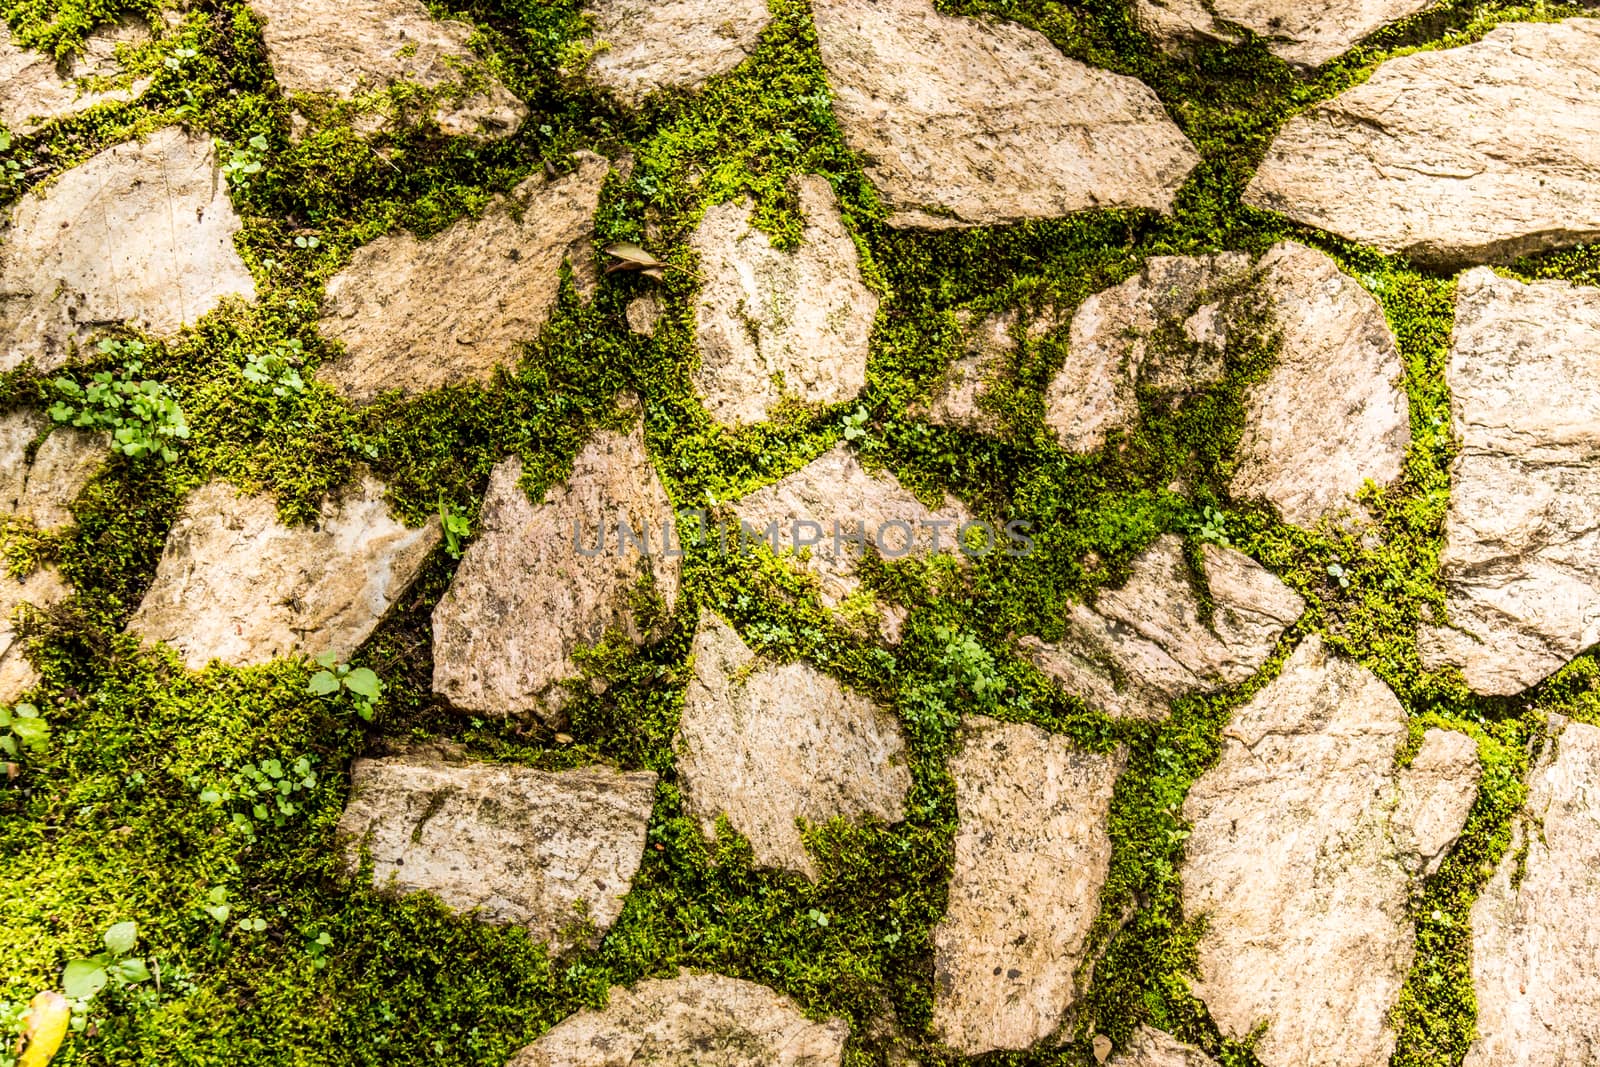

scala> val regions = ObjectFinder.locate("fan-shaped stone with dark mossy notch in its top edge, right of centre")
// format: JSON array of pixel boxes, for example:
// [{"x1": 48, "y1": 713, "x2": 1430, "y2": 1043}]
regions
[{"x1": 1021, "y1": 534, "x2": 1306, "y2": 720}]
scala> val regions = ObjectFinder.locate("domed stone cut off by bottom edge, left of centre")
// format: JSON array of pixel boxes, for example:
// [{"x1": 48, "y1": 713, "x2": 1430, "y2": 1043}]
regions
[{"x1": 506, "y1": 971, "x2": 850, "y2": 1067}]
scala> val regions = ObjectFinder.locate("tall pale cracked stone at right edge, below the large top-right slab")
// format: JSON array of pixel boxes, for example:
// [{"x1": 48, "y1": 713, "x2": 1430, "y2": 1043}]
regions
[{"x1": 1421, "y1": 269, "x2": 1600, "y2": 694}]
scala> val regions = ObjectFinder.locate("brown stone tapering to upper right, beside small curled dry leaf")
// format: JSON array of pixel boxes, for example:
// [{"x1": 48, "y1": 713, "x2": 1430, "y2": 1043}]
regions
[{"x1": 317, "y1": 152, "x2": 610, "y2": 402}]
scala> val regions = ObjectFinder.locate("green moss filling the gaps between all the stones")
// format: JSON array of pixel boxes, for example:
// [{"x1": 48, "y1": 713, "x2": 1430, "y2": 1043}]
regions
[{"x1": 0, "y1": 0, "x2": 1600, "y2": 1067}]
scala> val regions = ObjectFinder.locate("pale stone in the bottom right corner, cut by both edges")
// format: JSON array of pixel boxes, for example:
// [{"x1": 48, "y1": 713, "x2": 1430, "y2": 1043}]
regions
[{"x1": 1462, "y1": 723, "x2": 1600, "y2": 1067}]
